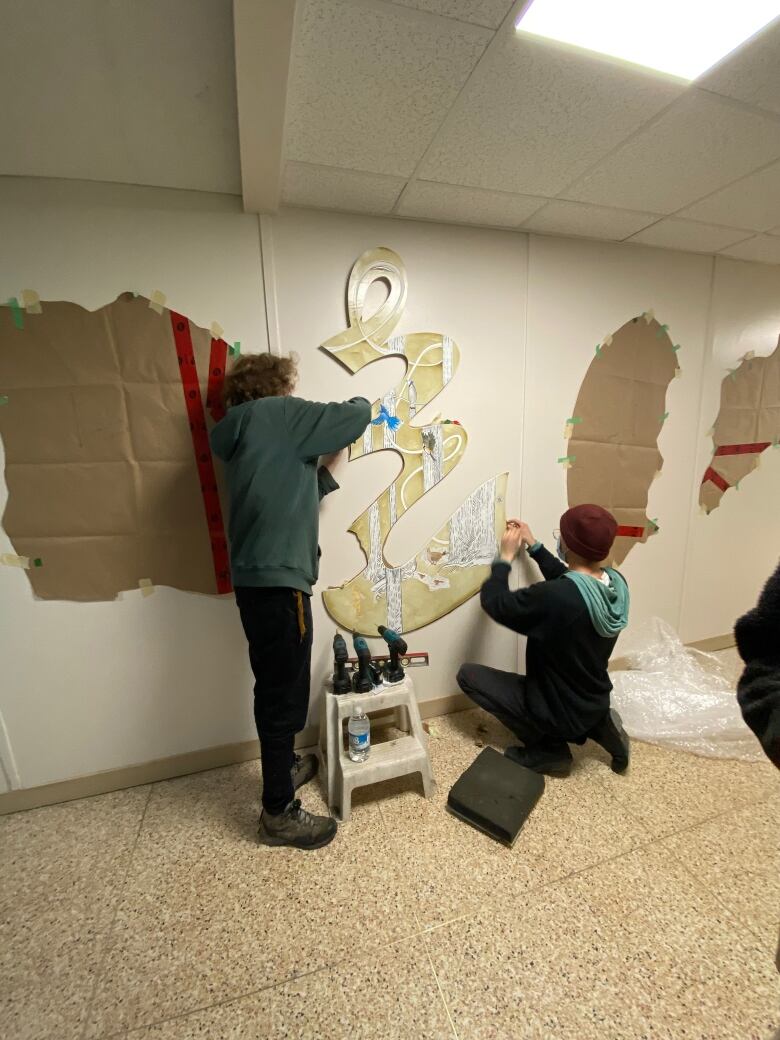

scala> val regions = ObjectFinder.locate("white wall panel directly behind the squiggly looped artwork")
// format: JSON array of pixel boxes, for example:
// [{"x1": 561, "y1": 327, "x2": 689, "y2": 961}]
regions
[{"x1": 272, "y1": 212, "x2": 526, "y2": 715}]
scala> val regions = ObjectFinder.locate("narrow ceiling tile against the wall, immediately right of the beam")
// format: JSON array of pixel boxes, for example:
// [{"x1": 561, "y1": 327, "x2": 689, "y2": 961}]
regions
[{"x1": 282, "y1": 162, "x2": 406, "y2": 213}]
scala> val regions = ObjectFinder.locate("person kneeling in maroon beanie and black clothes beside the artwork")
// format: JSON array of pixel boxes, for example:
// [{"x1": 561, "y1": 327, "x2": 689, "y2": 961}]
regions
[{"x1": 458, "y1": 505, "x2": 629, "y2": 776}]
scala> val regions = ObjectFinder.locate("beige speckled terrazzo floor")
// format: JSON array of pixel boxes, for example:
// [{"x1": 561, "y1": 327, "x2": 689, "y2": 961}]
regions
[{"x1": 0, "y1": 690, "x2": 780, "y2": 1040}]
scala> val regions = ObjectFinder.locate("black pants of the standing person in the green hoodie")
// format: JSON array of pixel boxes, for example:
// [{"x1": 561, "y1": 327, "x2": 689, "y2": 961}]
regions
[{"x1": 236, "y1": 587, "x2": 312, "y2": 815}]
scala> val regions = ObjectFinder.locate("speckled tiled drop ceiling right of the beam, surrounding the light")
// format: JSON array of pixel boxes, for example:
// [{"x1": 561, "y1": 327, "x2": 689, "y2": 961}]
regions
[{"x1": 285, "y1": 0, "x2": 780, "y2": 258}]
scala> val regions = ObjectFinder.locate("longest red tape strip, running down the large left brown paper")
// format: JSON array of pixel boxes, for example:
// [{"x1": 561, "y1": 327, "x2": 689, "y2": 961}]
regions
[{"x1": 171, "y1": 311, "x2": 233, "y2": 593}]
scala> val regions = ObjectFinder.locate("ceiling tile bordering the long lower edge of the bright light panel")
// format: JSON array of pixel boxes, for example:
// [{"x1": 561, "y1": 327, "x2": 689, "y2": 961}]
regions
[{"x1": 419, "y1": 33, "x2": 682, "y2": 195}]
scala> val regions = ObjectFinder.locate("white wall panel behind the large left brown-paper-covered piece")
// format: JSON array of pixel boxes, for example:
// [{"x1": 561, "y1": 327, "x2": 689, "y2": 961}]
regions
[{"x1": 0, "y1": 179, "x2": 266, "y2": 786}]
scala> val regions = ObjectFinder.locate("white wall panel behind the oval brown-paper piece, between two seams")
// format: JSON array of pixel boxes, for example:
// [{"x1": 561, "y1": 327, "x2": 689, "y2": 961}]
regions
[{"x1": 522, "y1": 236, "x2": 727, "y2": 634}]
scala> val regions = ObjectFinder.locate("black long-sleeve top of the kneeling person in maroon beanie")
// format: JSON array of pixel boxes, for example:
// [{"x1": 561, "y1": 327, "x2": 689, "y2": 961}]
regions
[{"x1": 480, "y1": 546, "x2": 617, "y2": 740}]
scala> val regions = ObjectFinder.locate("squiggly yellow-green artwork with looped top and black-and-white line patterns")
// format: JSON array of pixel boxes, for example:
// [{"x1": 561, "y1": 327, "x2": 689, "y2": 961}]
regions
[{"x1": 322, "y1": 249, "x2": 508, "y2": 635}]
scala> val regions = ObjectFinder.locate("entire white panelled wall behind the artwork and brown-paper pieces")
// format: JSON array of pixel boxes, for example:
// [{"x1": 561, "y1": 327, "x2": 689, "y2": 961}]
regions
[{"x1": 0, "y1": 179, "x2": 780, "y2": 790}]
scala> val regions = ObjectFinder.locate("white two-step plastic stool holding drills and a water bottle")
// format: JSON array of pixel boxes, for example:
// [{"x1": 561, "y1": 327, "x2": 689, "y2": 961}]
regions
[{"x1": 319, "y1": 675, "x2": 434, "y2": 821}]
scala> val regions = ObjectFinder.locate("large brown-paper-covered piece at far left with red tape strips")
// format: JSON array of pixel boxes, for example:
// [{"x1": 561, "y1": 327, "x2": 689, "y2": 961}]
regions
[{"x1": 0, "y1": 292, "x2": 231, "y2": 600}]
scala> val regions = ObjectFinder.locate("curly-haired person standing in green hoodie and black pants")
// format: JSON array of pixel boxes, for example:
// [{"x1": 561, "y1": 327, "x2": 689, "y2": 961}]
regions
[{"x1": 211, "y1": 354, "x2": 371, "y2": 849}]
